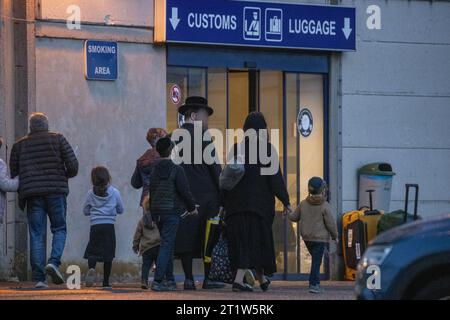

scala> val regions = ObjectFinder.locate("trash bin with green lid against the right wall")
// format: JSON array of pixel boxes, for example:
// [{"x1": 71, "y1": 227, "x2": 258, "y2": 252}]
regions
[{"x1": 358, "y1": 162, "x2": 395, "y2": 212}]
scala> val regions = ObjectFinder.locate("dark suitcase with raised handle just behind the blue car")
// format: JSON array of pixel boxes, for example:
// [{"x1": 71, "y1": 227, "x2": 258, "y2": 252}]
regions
[{"x1": 377, "y1": 184, "x2": 420, "y2": 234}]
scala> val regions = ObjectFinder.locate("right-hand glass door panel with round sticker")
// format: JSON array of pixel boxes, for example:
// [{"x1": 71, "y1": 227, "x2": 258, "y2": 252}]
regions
[{"x1": 284, "y1": 73, "x2": 328, "y2": 275}]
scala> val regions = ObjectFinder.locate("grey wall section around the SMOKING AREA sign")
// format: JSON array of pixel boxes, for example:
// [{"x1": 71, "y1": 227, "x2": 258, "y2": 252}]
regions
[{"x1": 31, "y1": 0, "x2": 166, "y2": 278}]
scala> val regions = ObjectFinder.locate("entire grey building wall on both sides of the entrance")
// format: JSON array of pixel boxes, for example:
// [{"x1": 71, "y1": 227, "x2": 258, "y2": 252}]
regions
[{"x1": 0, "y1": 0, "x2": 450, "y2": 278}]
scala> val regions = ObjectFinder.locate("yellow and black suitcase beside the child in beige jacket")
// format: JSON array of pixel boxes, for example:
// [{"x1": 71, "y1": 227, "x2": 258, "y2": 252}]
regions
[{"x1": 342, "y1": 190, "x2": 383, "y2": 280}]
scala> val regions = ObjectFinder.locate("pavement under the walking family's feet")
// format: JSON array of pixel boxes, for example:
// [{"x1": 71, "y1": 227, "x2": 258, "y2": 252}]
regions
[{"x1": 0, "y1": 281, "x2": 355, "y2": 300}]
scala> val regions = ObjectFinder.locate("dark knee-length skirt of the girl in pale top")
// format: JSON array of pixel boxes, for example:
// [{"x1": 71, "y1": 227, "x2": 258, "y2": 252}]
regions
[{"x1": 84, "y1": 224, "x2": 116, "y2": 262}]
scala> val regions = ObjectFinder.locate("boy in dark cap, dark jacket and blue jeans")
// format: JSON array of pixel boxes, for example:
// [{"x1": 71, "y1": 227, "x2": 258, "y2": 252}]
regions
[{"x1": 149, "y1": 137, "x2": 198, "y2": 291}]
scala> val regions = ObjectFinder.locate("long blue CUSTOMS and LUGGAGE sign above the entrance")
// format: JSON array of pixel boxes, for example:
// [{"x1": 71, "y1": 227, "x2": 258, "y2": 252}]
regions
[{"x1": 155, "y1": 0, "x2": 356, "y2": 51}]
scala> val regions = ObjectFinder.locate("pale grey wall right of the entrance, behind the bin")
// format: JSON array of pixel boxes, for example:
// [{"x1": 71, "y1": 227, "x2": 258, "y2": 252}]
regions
[{"x1": 342, "y1": 0, "x2": 450, "y2": 216}]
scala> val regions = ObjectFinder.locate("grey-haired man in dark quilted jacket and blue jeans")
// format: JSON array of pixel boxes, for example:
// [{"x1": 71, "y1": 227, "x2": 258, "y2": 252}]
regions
[{"x1": 10, "y1": 113, "x2": 78, "y2": 288}]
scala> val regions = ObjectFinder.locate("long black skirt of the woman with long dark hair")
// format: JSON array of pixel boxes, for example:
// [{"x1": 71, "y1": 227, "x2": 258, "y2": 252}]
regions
[{"x1": 225, "y1": 212, "x2": 277, "y2": 274}]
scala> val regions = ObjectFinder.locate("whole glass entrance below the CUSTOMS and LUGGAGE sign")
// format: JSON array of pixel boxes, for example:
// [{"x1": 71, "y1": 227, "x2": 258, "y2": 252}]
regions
[{"x1": 167, "y1": 66, "x2": 328, "y2": 279}]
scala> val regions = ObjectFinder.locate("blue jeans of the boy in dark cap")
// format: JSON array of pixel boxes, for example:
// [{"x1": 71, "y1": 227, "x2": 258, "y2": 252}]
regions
[{"x1": 154, "y1": 214, "x2": 180, "y2": 282}]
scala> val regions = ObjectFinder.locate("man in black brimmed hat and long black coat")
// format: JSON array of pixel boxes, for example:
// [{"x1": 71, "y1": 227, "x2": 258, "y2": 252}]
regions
[{"x1": 175, "y1": 96, "x2": 224, "y2": 290}]
